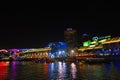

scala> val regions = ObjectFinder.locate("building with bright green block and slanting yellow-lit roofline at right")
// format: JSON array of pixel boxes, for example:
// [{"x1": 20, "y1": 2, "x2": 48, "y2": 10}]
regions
[{"x1": 78, "y1": 35, "x2": 120, "y2": 55}]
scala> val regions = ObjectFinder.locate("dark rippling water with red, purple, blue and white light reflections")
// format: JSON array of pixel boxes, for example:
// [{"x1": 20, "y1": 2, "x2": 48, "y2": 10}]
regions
[{"x1": 0, "y1": 61, "x2": 120, "y2": 80}]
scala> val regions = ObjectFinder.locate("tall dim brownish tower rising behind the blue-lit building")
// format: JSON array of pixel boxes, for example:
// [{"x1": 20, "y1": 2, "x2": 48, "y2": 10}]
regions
[{"x1": 64, "y1": 28, "x2": 78, "y2": 53}]
